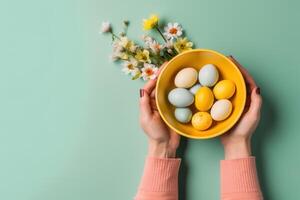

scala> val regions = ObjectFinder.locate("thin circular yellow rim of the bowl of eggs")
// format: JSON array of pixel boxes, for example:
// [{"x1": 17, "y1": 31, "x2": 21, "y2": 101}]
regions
[{"x1": 155, "y1": 49, "x2": 247, "y2": 139}]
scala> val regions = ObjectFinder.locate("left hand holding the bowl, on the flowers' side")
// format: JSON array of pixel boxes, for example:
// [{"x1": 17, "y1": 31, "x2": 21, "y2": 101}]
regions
[{"x1": 140, "y1": 63, "x2": 180, "y2": 158}]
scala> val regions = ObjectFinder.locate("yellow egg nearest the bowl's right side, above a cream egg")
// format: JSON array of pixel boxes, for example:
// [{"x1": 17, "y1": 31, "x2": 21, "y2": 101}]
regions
[{"x1": 213, "y1": 80, "x2": 235, "y2": 99}]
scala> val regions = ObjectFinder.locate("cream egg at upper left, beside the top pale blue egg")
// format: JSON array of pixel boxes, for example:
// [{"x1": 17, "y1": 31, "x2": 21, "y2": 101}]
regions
[{"x1": 174, "y1": 67, "x2": 198, "y2": 88}]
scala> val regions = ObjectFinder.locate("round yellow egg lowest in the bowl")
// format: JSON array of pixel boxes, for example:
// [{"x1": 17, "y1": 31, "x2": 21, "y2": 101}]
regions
[{"x1": 192, "y1": 112, "x2": 212, "y2": 131}]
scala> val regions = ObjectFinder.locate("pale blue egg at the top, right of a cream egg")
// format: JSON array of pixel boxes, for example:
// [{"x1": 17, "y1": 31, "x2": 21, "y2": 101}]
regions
[{"x1": 199, "y1": 64, "x2": 219, "y2": 87}]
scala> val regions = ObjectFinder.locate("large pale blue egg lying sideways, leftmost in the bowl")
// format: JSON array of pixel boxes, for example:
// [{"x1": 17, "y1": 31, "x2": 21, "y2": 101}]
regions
[{"x1": 168, "y1": 88, "x2": 194, "y2": 108}]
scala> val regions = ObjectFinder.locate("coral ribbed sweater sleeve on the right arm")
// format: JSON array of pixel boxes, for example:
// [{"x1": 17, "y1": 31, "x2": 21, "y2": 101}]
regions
[{"x1": 221, "y1": 157, "x2": 263, "y2": 200}]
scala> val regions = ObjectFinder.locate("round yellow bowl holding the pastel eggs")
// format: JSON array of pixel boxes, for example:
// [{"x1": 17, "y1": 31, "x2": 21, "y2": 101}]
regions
[{"x1": 156, "y1": 49, "x2": 246, "y2": 139}]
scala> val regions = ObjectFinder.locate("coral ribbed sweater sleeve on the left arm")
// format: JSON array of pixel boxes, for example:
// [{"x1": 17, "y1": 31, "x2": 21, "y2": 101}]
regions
[{"x1": 135, "y1": 157, "x2": 181, "y2": 200}]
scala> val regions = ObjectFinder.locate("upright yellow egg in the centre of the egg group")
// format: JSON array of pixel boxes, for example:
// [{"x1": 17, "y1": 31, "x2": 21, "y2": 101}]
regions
[{"x1": 195, "y1": 87, "x2": 214, "y2": 111}]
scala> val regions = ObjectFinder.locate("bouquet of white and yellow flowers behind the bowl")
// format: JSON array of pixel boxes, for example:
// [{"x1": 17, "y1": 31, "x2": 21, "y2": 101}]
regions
[{"x1": 101, "y1": 15, "x2": 193, "y2": 81}]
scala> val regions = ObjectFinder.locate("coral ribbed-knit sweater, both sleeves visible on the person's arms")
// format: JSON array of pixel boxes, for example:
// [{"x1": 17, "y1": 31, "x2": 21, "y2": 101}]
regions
[{"x1": 135, "y1": 157, "x2": 263, "y2": 200}]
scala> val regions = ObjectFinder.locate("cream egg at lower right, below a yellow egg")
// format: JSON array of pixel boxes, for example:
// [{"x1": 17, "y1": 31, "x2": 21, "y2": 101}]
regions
[{"x1": 210, "y1": 99, "x2": 232, "y2": 121}]
